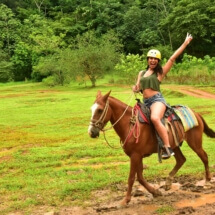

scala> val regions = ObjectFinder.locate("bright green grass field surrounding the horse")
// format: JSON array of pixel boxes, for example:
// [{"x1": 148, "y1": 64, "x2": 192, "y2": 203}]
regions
[{"x1": 0, "y1": 83, "x2": 215, "y2": 214}]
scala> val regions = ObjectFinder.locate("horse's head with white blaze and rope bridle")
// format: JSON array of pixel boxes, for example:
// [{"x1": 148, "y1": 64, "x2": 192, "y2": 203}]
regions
[{"x1": 88, "y1": 91, "x2": 111, "y2": 138}]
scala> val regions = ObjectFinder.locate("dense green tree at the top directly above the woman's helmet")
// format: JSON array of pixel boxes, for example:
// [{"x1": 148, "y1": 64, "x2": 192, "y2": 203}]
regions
[{"x1": 120, "y1": 0, "x2": 169, "y2": 53}]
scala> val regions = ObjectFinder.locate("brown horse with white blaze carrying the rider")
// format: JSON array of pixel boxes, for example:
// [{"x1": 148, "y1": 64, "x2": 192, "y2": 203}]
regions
[{"x1": 88, "y1": 91, "x2": 215, "y2": 205}]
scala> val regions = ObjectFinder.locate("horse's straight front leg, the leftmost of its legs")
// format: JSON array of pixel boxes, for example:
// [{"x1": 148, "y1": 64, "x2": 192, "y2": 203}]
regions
[{"x1": 121, "y1": 154, "x2": 141, "y2": 206}]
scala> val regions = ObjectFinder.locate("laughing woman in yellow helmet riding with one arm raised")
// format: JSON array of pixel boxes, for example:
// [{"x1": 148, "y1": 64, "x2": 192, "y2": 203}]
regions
[{"x1": 132, "y1": 33, "x2": 193, "y2": 159}]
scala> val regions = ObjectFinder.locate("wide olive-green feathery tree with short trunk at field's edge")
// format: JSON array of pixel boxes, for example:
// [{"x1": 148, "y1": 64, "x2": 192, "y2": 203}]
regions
[{"x1": 33, "y1": 31, "x2": 121, "y2": 87}]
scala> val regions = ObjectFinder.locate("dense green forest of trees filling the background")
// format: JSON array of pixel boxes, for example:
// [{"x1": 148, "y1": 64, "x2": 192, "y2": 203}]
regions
[{"x1": 0, "y1": 0, "x2": 215, "y2": 86}]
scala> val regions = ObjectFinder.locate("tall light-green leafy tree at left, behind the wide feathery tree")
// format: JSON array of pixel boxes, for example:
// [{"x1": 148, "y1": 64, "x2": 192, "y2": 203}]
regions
[{"x1": 25, "y1": 15, "x2": 63, "y2": 81}]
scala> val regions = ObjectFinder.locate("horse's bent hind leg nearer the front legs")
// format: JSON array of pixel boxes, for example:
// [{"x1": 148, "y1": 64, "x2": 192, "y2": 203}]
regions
[{"x1": 165, "y1": 147, "x2": 186, "y2": 190}]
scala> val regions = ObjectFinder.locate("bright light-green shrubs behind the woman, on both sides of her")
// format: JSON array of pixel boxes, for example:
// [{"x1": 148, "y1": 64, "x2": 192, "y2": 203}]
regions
[{"x1": 114, "y1": 54, "x2": 215, "y2": 85}]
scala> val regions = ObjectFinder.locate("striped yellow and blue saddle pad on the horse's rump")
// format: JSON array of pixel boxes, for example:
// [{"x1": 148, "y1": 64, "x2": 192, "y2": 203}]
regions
[{"x1": 173, "y1": 105, "x2": 198, "y2": 132}]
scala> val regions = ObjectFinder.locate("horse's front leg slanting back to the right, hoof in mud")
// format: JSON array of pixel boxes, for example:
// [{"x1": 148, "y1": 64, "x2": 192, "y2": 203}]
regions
[{"x1": 137, "y1": 159, "x2": 162, "y2": 197}]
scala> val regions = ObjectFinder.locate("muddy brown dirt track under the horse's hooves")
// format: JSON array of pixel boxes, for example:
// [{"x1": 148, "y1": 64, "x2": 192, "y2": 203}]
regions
[{"x1": 92, "y1": 177, "x2": 215, "y2": 215}]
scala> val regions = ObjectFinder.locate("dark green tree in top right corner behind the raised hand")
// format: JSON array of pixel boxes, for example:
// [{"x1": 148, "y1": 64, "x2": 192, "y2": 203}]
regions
[{"x1": 160, "y1": 0, "x2": 215, "y2": 57}]
